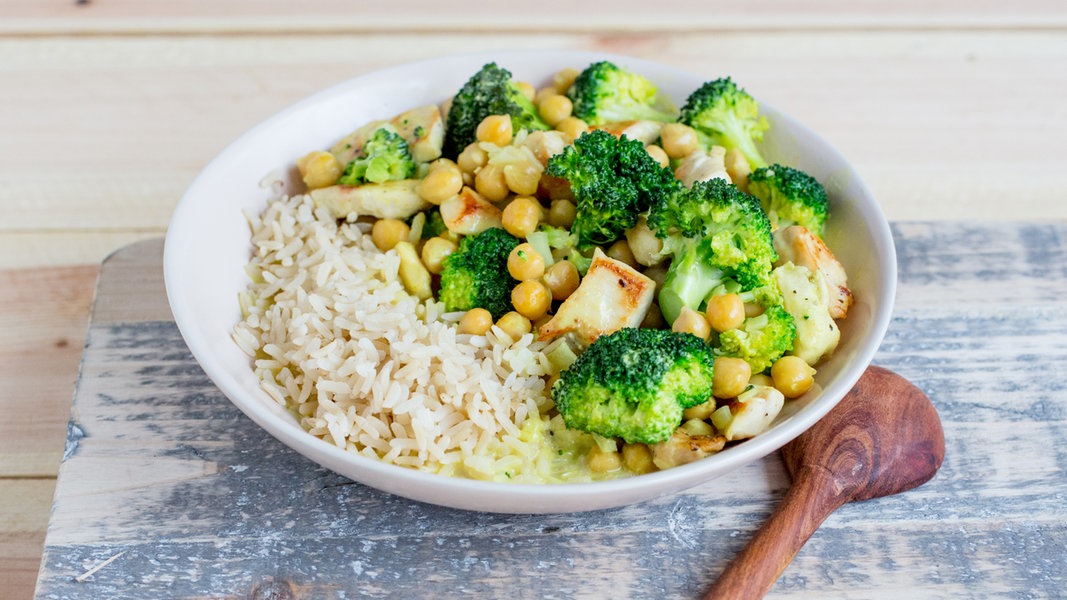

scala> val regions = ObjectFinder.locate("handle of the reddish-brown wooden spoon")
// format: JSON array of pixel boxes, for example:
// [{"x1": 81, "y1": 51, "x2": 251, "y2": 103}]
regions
[{"x1": 704, "y1": 467, "x2": 848, "y2": 600}]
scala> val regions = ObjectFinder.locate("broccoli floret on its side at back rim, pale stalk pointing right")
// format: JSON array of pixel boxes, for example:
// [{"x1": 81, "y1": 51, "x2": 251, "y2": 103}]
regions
[{"x1": 567, "y1": 61, "x2": 675, "y2": 125}]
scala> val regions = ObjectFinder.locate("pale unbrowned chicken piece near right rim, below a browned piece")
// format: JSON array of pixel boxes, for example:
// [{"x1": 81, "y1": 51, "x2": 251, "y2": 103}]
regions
[{"x1": 774, "y1": 263, "x2": 841, "y2": 365}]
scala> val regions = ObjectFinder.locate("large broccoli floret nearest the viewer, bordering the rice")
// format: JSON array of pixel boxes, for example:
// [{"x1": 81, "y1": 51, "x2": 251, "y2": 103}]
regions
[{"x1": 552, "y1": 328, "x2": 714, "y2": 444}]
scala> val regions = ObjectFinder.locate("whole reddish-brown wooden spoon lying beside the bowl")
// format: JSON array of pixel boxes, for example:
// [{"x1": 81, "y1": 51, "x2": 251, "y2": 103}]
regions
[{"x1": 704, "y1": 366, "x2": 944, "y2": 600}]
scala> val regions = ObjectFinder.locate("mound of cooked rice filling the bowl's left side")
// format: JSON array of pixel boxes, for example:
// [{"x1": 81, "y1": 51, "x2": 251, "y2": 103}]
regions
[{"x1": 234, "y1": 174, "x2": 553, "y2": 480}]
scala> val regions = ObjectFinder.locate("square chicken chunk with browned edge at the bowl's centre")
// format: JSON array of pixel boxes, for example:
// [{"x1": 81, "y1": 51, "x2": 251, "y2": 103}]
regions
[{"x1": 539, "y1": 249, "x2": 656, "y2": 346}]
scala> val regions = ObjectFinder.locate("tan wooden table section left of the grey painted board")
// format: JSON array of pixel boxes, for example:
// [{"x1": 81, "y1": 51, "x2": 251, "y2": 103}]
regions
[{"x1": 0, "y1": 266, "x2": 98, "y2": 599}]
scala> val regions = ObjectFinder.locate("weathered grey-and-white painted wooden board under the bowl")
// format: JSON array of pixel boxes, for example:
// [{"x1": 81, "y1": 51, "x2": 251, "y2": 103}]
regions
[{"x1": 36, "y1": 223, "x2": 1067, "y2": 599}]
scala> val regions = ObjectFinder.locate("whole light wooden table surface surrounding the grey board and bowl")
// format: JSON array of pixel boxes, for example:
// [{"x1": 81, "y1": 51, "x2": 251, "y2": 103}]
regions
[{"x1": 0, "y1": 0, "x2": 1067, "y2": 600}]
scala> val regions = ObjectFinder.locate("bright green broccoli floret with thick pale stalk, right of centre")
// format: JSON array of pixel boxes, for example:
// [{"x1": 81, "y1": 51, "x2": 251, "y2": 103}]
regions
[{"x1": 648, "y1": 179, "x2": 778, "y2": 322}]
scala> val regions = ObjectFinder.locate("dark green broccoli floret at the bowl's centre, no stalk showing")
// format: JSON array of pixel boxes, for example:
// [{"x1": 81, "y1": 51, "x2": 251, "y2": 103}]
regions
[{"x1": 546, "y1": 129, "x2": 682, "y2": 248}]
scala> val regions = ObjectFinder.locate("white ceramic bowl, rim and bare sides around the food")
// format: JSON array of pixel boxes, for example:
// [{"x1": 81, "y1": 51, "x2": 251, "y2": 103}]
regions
[{"x1": 163, "y1": 51, "x2": 896, "y2": 512}]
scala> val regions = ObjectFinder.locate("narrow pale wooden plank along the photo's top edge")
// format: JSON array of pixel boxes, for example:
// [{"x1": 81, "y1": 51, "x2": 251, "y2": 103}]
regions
[{"x1": 0, "y1": 0, "x2": 1067, "y2": 33}]
